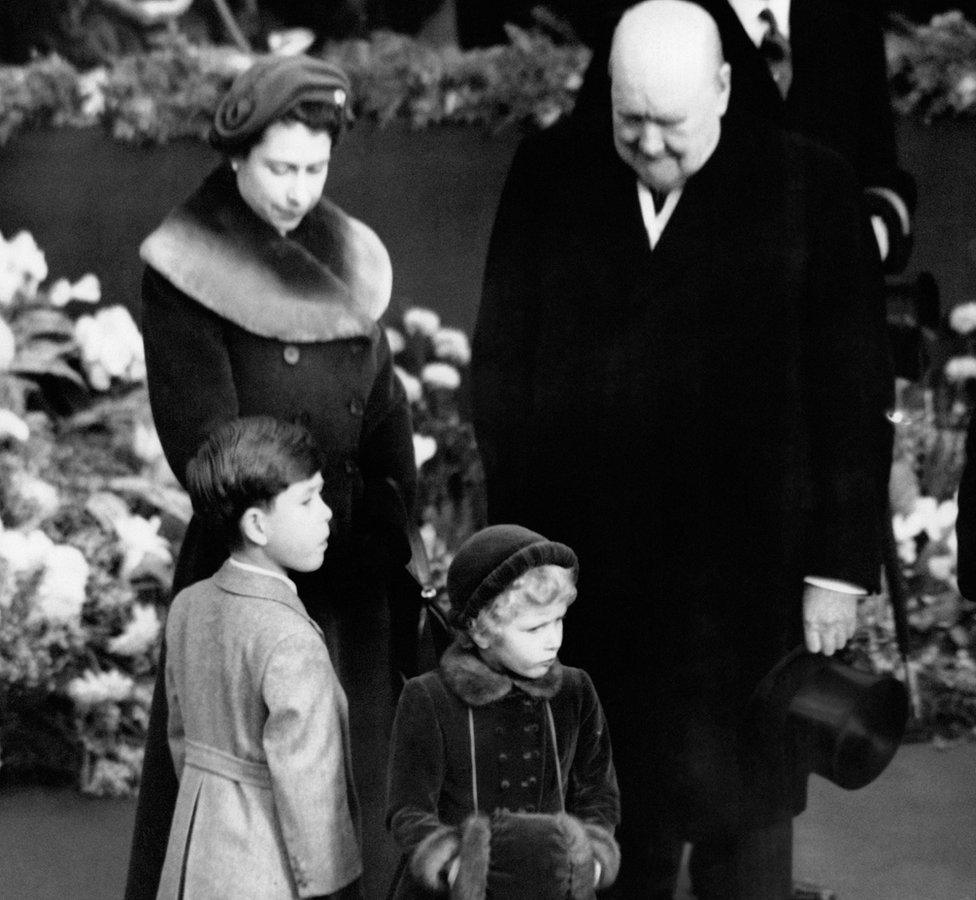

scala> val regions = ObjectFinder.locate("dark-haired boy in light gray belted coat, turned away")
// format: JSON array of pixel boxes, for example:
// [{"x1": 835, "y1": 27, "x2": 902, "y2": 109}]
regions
[{"x1": 158, "y1": 416, "x2": 362, "y2": 900}]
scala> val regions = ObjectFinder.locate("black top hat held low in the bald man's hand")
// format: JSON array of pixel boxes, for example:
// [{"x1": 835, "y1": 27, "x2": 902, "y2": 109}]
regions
[{"x1": 750, "y1": 646, "x2": 908, "y2": 790}]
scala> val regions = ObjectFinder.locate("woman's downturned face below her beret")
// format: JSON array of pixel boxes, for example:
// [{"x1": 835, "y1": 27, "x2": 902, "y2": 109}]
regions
[{"x1": 231, "y1": 122, "x2": 332, "y2": 235}]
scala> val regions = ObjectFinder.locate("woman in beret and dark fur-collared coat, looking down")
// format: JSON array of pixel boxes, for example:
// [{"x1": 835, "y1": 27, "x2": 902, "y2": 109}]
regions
[{"x1": 126, "y1": 57, "x2": 416, "y2": 898}]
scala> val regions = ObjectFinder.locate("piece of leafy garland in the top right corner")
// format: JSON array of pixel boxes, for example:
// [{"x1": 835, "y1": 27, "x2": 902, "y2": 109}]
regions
[{"x1": 887, "y1": 11, "x2": 976, "y2": 121}]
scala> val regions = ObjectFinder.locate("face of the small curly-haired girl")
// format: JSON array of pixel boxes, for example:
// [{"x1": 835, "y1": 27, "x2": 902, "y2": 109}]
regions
[{"x1": 472, "y1": 598, "x2": 569, "y2": 678}]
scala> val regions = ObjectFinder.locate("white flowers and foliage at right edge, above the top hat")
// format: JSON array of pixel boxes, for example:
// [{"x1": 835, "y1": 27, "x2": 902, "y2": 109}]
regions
[{"x1": 858, "y1": 302, "x2": 976, "y2": 740}]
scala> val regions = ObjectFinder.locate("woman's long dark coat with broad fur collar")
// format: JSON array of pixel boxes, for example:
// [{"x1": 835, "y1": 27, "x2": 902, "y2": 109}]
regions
[{"x1": 127, "y1": 167, "x2": 416, "y2": 898}]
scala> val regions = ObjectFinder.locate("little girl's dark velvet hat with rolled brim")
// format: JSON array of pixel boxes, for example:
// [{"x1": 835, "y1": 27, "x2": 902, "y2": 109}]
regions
[{"x1": 447, "y1": 525, "x2": 579, "y2": 623}]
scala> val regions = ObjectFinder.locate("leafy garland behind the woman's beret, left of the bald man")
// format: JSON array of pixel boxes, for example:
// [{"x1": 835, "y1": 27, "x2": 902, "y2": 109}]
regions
[{"x1": 0, "y1": 26, "x2": 590, "y2": 144}]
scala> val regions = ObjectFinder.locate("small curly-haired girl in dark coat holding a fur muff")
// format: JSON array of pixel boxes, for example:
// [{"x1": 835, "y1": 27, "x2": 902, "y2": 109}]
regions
[{"x1": 387, "y1": 525, "x2": 620, "y2": 900}]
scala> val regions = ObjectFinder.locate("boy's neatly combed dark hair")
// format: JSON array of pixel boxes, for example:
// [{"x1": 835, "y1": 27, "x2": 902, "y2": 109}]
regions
[{"x1": 186, "y1": 416, "x2": 322, "y2": 550}]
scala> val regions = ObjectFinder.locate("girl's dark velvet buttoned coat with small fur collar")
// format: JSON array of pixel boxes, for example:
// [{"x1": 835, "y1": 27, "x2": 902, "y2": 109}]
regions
[{"x1": 387, "y1": 643, "x2": 620, "y2": 898}]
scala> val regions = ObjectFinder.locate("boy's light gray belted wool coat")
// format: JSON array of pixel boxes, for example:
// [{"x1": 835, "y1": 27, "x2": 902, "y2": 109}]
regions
[{"x1": 158, "y1": 562, "x2": 362, "y2": 900}]
